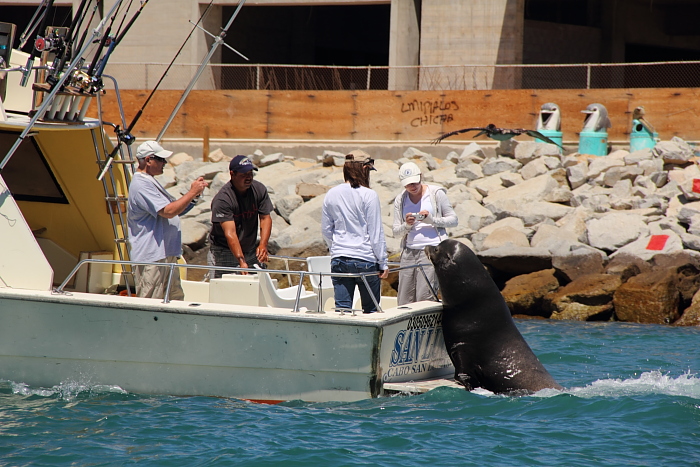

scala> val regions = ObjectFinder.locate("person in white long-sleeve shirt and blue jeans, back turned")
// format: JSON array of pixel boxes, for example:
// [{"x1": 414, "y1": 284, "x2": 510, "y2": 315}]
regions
[{"x1": 321, "y1": 155, "x2": 389, "y2": 313}]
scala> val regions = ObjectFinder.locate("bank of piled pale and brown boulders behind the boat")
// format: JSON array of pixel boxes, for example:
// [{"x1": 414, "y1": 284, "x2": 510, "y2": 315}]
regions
[{"x1": 160, "y1": 138, "x2": 700, "y2": 326}]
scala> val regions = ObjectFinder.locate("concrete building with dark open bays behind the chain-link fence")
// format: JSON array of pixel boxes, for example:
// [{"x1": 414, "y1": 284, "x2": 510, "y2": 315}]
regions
[{"x1": 0, "y1": 0, "x2": 700, "y2": 90}]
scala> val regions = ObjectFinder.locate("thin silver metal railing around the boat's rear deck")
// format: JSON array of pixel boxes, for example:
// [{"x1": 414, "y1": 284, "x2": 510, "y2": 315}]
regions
[{"x1": 53, "y1": 255, "x2": 438, "y2": 315}]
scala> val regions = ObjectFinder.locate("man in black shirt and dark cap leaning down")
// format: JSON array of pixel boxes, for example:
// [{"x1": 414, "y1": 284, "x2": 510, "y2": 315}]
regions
[{"x1": 207, "y1": 156, "x2": 273, "y2": 278}]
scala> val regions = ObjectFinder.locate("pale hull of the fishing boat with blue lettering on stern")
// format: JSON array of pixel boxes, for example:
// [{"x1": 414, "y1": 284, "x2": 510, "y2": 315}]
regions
[{"x1": 0, "y1": 289, "x2": 454, "y2": 402}]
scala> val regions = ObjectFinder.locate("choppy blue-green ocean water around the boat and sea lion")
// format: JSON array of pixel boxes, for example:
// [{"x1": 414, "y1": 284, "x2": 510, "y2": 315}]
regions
[{"x1": 0, "y1": 321, "x2": 700, "y2": 466}]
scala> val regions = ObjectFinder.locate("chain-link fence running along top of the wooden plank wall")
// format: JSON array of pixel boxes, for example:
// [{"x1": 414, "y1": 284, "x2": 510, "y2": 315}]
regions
[{"x1": 107, "y1": 61, "x2": 700, "y2": 91}]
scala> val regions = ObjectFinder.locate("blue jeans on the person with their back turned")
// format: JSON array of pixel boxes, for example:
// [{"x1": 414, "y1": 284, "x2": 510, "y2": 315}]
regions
[{"x1": 331, "y1": 256, "x2": 381, "y2": 313}]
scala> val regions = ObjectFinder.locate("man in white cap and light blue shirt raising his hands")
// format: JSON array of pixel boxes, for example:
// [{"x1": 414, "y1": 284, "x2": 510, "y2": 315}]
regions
[{"x1": 128, "y1": 141, "x2": 208, "y2": 300}]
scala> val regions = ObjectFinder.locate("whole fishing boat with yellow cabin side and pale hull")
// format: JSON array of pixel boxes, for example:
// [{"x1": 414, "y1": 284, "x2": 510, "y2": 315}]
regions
[{"x1": 0, "y1": 1, "x2": 454, "y2": 403}]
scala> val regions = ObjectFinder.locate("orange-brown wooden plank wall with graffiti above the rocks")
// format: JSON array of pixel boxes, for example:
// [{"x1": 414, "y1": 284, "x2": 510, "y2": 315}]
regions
[{"x1": 91, "y1": 88, "x2": 700, "y2": 142}]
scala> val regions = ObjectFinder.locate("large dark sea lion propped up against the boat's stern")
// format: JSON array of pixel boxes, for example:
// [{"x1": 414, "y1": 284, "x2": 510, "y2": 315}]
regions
[{"x1": 425, "y1": 240, "x2": 562, "y2": 394}]
